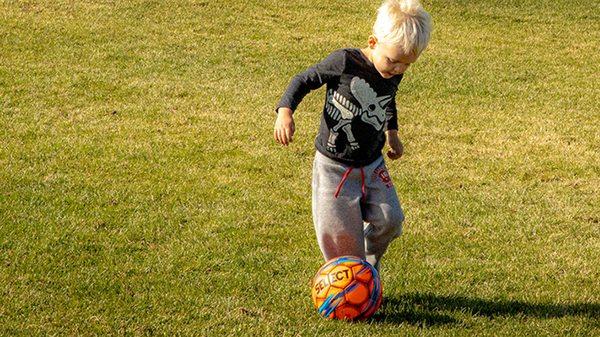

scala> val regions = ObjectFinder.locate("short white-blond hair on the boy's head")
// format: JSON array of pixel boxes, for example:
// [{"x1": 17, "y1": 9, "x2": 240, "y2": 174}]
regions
[{"x1": 373, "y1": 0, "x2": 431, "y2": 55}]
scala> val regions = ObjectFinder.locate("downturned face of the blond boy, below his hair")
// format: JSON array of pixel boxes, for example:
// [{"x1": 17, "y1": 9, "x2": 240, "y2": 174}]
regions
[{"x1": 369, "y1": 36, "x2": 419, "y2": 78}]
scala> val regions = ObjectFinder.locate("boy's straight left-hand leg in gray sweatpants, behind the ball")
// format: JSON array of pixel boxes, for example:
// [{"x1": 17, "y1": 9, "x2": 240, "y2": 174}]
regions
[{"x1": 312, "y1": 152, "x2": 365, "y2": 261}]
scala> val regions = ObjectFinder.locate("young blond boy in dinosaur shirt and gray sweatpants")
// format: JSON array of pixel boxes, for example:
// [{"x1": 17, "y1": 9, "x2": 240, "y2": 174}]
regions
[{"x1": 274, "y1": 0, "x2": 431, "y2": 269}]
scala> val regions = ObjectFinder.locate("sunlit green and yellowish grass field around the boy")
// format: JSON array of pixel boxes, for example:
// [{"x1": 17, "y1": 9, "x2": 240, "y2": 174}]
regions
[{"x1": 0, "y1": 0, "x2": 600, "y2": 336}]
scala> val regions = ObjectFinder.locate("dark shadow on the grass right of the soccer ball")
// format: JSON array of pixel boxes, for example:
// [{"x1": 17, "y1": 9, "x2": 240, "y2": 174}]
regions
[{"x1": 373, "y1": 293, "x2": 600, "y2": 327}]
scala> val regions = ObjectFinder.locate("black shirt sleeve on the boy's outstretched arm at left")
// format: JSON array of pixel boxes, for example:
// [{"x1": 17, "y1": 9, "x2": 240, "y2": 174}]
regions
[{"x1": 275, "y1": 49, "x2": 346, "y2": 112}]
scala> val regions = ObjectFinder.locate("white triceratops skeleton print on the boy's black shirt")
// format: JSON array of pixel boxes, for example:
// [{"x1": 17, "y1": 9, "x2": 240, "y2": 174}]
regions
[{"x1": 327, "y1": 76, "x2": 391, "y2": 153}]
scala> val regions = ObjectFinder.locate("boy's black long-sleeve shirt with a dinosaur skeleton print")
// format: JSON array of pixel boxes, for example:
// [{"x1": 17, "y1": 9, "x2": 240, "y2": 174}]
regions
[{"x1": 277, "y1": 48, "x2": 402, "y2": 167}]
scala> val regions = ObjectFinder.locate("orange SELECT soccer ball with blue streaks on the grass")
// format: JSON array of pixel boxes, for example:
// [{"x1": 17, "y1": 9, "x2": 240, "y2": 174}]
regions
[{"x1": 312, "y1": 256, "x2": 382, "y2": 320}]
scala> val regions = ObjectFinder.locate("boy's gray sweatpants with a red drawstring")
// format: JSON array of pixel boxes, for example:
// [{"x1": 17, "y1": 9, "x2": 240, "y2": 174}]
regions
[{"x1": 312, "y1": 151, "x2": 404, "y2": 269}]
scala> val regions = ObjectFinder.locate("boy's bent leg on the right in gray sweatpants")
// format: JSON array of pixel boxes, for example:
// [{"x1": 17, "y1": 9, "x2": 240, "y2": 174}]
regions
[{"x1": 363, "y1": 159, "x2": 404, "y2": 269}]
